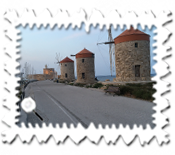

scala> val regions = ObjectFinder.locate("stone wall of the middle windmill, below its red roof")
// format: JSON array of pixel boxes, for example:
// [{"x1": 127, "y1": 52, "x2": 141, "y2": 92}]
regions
[{"x1": 76, "y1": 58, "x2": 95, "y2": 83}]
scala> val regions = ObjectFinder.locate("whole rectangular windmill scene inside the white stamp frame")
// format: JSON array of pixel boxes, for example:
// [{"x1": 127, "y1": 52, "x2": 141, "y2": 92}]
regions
[{"x1": 17, "y1": 24, "x2": 156, "y2": 128}]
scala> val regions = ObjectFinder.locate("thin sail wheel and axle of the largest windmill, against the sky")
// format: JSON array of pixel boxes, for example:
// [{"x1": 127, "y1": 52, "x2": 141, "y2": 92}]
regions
[{"x1": 97, "y1": 27, "x2": 115, "y2": 76}]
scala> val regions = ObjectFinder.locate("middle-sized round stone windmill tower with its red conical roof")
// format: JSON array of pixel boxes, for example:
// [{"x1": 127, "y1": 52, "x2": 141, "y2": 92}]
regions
[{"x1": 76, "y1": 48, "x2": 95, "y2": 84}]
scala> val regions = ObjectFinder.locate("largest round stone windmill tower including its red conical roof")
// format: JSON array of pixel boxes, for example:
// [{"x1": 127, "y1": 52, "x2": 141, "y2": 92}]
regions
[{"x1": 114, "y1": 26, "x2": 150, "y2": 82}]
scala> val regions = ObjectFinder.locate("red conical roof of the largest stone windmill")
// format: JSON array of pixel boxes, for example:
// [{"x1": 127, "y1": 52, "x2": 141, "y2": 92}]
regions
[{"x1": 114, "y1": 26, "x2": 149, "y2": 44}]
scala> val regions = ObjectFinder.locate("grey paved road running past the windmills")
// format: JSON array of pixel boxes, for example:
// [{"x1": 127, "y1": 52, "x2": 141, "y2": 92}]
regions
[{"x1": 17, "y1": 80, "x2": 154, "y2": 127}]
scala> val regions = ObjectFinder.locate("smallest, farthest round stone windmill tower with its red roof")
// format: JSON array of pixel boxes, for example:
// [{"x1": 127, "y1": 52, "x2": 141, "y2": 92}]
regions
[{"x1": 60, "y1": 57, "x2": 75, "y2": 81}]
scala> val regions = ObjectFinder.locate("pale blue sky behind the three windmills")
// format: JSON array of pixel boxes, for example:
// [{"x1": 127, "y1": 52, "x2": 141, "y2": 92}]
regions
[{"x1": 17, "y1": 24, "x2": 156, "y2": 76}]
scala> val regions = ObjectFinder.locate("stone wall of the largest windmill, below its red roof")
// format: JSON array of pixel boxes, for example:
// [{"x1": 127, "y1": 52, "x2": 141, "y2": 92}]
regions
[{"x1": 114, "y1": 40, "x2": 150, "y2": 82}]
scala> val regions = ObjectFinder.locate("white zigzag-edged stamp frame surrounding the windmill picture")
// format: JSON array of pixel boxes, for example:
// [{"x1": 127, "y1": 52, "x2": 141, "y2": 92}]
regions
[{"x1": 0, "y1": 8, "x2": 170, "y2": 144}]
